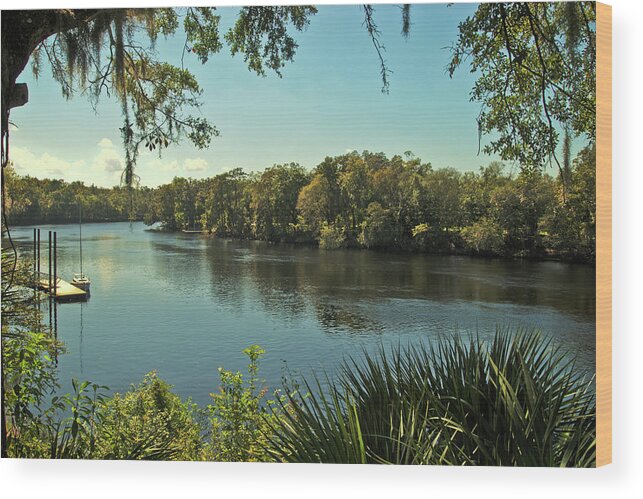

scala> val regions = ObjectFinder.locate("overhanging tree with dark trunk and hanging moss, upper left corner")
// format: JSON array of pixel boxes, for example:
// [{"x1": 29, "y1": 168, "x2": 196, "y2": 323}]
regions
[{"x1": 2, "y1": 6, "x2": 317, "y2": 182}]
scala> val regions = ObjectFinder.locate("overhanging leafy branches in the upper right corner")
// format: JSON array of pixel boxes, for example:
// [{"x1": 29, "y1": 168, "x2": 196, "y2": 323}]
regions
[{"x1": 448, "y1": 2, "x2": 596, "y2": 178}]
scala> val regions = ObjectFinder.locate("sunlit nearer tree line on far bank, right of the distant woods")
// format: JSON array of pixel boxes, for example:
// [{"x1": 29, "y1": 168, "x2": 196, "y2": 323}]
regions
[{"x1": 144, "y1": 146, "x2": 596, "y2": 262}]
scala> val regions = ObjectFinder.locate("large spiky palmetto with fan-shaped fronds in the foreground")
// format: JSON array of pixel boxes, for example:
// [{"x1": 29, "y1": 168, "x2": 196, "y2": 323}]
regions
[{"x1": 270, "y1": 331, "x2": 596, "y2": 467}]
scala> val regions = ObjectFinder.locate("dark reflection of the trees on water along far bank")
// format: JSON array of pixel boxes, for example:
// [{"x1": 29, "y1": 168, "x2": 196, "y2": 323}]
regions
[{"x1": 194, "y1": 239, "x2": 595, "y2": 320}]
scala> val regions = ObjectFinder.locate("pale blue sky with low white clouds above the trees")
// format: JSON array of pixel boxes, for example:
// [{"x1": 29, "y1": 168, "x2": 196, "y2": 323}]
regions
[{"x1": 10, "y1": 4, "x2": 506, "y2": 187}]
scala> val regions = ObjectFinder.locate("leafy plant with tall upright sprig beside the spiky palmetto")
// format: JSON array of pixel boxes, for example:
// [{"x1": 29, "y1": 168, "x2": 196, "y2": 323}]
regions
[{"x1": 207, "y1": 345, "x2": 281, "y2": 461}]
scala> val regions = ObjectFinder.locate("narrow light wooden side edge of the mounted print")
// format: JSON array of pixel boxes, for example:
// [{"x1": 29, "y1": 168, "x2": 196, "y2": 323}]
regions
[{"x1": 596, "y1": 3, "x2": 612, "y2": 466}]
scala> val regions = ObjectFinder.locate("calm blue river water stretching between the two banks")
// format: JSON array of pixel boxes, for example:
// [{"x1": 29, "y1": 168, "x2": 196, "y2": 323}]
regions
[{"x1": 7, "y1": 223, "x2": 595, "y2": 403}]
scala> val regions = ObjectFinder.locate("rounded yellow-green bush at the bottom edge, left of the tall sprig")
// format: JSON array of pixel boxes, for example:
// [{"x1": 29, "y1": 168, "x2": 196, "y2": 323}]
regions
[{"x1": 93, "y1": 372, "x2": 203, "y2": 461}]
